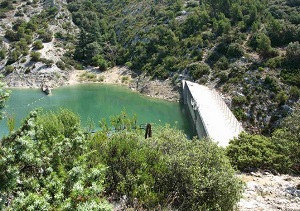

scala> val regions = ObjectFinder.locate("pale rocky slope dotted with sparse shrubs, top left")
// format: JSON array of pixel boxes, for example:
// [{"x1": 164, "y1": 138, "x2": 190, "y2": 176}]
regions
[{"x1": 0, "y1": 0, "x2": 77, "y2": 87}]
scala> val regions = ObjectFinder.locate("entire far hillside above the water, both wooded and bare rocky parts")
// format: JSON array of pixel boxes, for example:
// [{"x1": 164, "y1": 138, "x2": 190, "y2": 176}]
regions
[{"x1": 0, "y1": 0, "x2": 300, "y2": 135}]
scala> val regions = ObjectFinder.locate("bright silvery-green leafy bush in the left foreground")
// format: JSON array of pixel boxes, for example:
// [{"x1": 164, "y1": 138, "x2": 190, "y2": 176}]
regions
[{"x1": 0, "y1": 109, "x2": 112, "y2": 210}]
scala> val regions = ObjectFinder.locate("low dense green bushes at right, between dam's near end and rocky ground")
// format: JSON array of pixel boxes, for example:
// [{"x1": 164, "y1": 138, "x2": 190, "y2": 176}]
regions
[{"x1": 226, "y1": 103, "x2": 300, "y2": 174}]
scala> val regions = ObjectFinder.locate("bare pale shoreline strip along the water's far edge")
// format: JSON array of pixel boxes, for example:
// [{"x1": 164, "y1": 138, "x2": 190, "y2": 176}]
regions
[{"x1": 3, "y1": 67, "x2": 180, "y2": 102}]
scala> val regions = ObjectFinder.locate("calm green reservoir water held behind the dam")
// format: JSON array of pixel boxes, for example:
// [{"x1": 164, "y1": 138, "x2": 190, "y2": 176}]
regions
[{"x1": 0, "y1": 84, "x2": 195, "y2": 137}]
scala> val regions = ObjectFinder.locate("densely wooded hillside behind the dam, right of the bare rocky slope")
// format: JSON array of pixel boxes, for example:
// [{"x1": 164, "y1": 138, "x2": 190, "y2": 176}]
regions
[{"x1": 63, "y1": 0, "x2": 300, "y2": 135}]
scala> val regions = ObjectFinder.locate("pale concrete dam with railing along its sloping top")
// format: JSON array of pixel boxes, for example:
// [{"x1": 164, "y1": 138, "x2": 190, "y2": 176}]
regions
[{"x1": 182, "y1": 80, "x2": 243, "y2": 146}]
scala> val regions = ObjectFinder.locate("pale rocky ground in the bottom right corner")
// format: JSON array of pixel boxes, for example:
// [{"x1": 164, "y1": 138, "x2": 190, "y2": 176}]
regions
[{"x1": 237, "y1": 172, "x2": 300, "y2": 211}]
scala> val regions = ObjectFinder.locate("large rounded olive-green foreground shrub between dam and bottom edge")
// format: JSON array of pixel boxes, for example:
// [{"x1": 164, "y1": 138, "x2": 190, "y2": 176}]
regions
[{"x1": 91, "y1": 123, "x2": 242, "y2": 210}]
